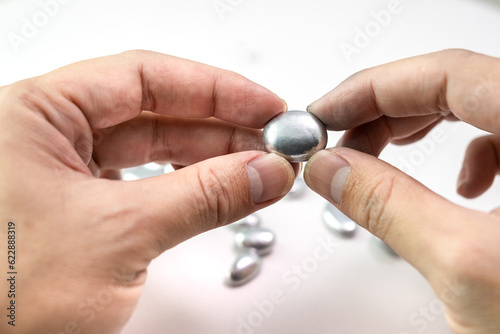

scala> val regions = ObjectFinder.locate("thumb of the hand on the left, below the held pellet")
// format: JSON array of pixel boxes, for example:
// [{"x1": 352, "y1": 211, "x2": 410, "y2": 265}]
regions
[{"x1": 126, "y1": 151, "x2": 295, "y2": 253}]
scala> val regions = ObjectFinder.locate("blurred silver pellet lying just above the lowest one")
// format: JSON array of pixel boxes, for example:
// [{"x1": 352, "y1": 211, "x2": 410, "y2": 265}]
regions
[{"x1": 234, "y1": 228, "x2": 276, "y2": 256}]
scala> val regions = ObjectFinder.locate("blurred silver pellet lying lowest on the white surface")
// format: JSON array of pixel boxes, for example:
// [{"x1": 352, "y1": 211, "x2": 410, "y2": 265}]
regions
[{"x1": 226, "y1": 251, "x2": 262, "y2": 286}]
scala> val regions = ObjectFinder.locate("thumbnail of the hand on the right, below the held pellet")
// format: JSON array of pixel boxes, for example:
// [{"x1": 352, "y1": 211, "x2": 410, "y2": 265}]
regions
[{"x1": 304, "y1": 150, "x2": 351, "y2": 204}]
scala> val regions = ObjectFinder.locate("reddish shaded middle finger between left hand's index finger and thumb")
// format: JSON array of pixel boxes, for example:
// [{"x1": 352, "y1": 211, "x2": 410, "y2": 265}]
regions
[{"x1": 93, "y1": 112, "x2": 265, "y2": 168}]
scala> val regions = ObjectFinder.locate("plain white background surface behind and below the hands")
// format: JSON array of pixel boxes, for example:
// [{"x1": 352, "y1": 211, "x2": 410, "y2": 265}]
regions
[{"x1": 0, "y1": 0, "x2": 500, "y2": 334}]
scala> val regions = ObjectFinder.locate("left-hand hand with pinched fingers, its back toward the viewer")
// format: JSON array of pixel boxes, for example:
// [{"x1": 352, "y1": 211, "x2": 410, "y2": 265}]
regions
[{"x1": 0, "y1": 51, "x2": 295, "y2": 333}]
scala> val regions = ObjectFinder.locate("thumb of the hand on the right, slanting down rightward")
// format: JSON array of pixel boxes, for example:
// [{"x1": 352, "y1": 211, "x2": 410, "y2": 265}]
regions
[{"x1": 304, "y1": 148, "x2": 467, "y2": 275}]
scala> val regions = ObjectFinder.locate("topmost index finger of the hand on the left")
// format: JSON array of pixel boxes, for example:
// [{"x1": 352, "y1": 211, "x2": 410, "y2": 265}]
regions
[{"x1": 43, "y1": 51, "x2": 286, "y2": 129}]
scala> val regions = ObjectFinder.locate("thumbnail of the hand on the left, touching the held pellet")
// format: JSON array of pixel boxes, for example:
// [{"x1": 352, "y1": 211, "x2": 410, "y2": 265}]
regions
[{"x1": 247, "y1": 154, "x2": 295, "y2": 204}]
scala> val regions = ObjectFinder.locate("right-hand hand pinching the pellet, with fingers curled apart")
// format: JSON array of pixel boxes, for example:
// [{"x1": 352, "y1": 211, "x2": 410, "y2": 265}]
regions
[{"x1": 304, "y1": 50, "x2": 500, "y2": 334}]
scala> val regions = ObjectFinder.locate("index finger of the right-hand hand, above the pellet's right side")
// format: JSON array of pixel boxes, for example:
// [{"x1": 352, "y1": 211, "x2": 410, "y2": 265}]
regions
[{"x1": 308, "y1": 50, "x2": 500, "y2": 132}]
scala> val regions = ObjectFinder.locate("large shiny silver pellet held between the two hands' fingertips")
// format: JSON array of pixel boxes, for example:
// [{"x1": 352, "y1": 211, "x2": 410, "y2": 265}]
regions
[{"x1": 263, "y1": 110, "x2": 328, "y2": 162}]
